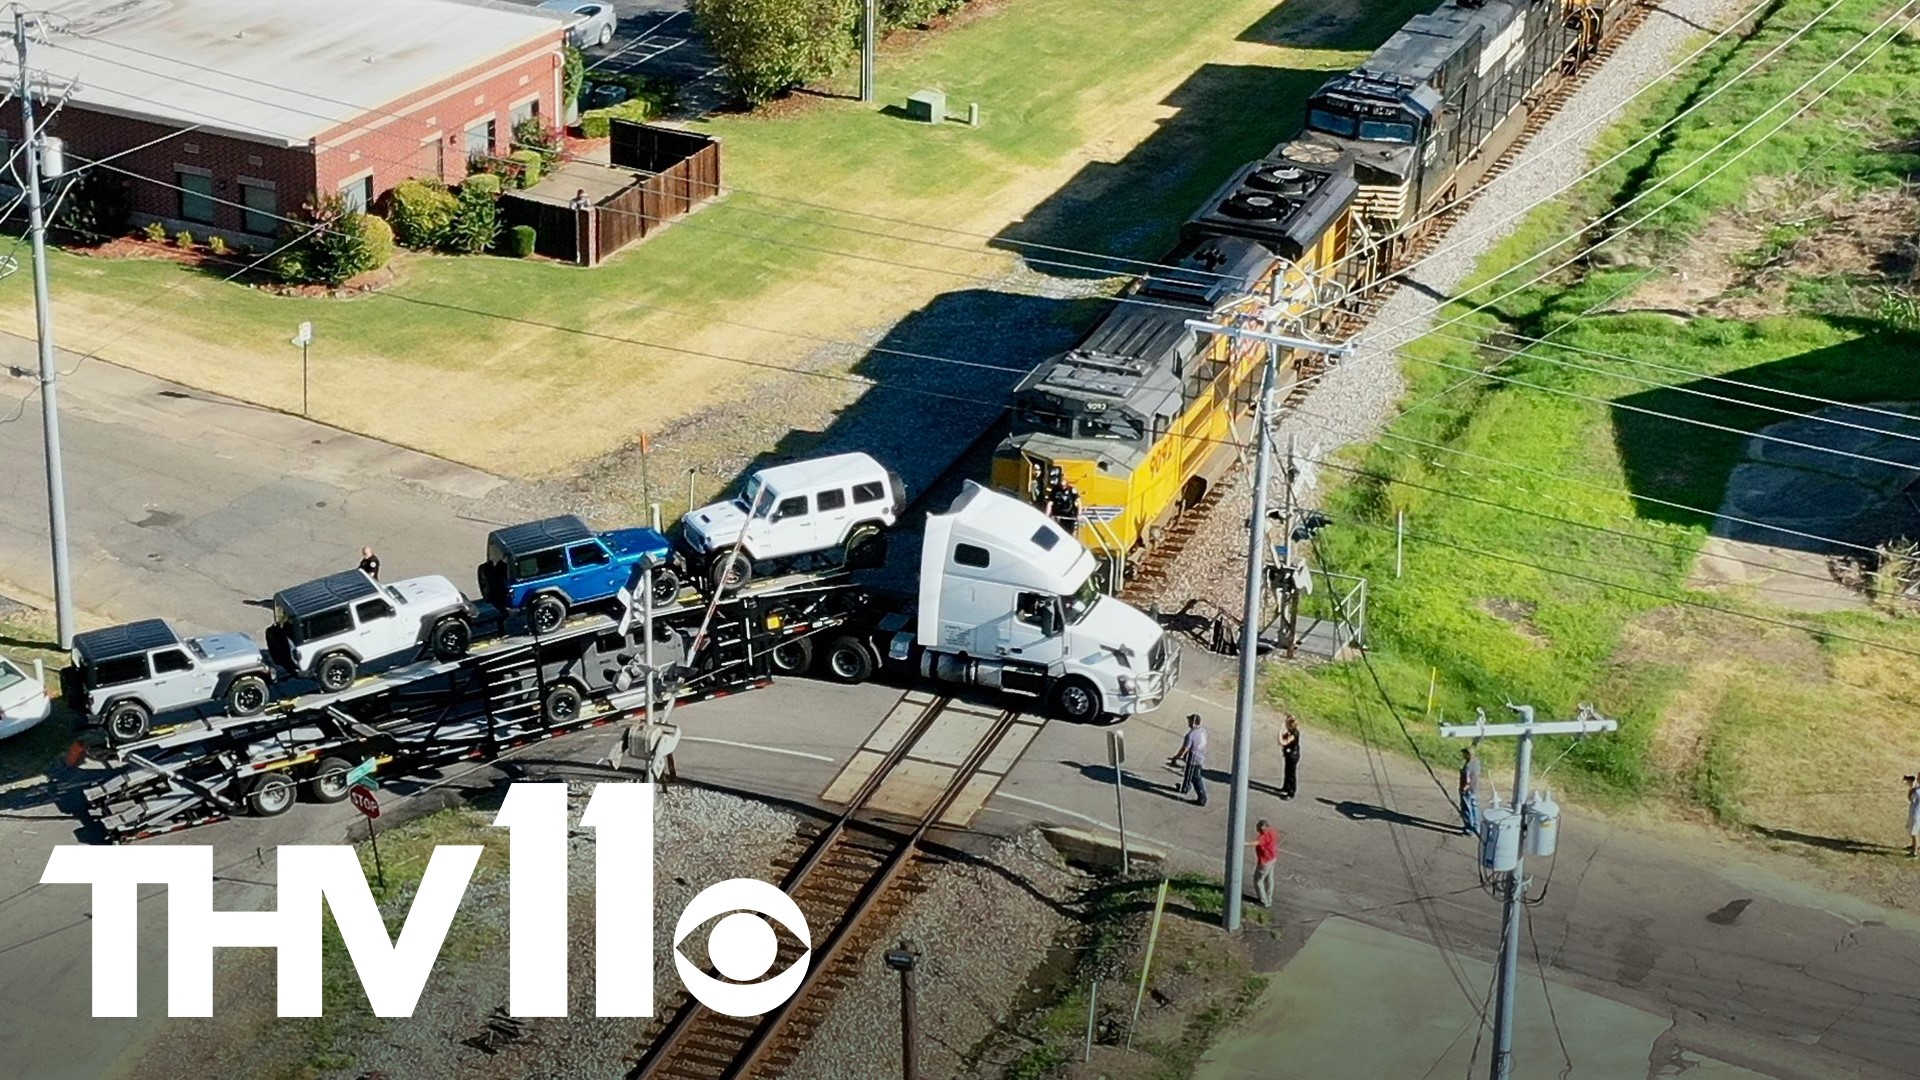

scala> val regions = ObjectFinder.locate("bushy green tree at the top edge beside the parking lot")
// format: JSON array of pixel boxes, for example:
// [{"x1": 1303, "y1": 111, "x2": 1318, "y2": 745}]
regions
[{"x1": 693, "y1": 0, "x2": 862, "y2": 106}]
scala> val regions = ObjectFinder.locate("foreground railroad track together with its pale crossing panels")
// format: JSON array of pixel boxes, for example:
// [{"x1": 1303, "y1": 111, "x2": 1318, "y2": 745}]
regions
[{"x1": 628, "y1": 690, "x2": 1041, "y2": 1080}]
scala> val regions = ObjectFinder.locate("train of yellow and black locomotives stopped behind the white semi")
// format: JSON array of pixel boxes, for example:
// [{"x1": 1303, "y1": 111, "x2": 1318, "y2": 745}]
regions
[{"x1": 993, "y1": 0, "x2": 1632, "y2": 565}]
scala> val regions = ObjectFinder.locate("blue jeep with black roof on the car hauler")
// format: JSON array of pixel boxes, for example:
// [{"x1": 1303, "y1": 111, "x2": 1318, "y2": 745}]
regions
[{"x1": 480, "y1": 513, "x2": 680, "y2": 634}]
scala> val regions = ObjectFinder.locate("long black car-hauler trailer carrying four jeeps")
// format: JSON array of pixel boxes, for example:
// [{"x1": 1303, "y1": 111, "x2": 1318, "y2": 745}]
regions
[{"x1": 84, "y1": 578, "x2": 864, "y2": 842}]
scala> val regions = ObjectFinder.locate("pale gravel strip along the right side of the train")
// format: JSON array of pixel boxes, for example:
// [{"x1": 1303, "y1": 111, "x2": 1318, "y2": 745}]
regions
[{"x1": 1140, "y1": 0, "x2": 1751, "y2": 617}]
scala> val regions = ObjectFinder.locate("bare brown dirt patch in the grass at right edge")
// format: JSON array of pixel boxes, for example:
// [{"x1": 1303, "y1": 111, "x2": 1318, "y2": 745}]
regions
[{"x1": 1603, "y1": 181, "x2": 1920, "y2": 319}]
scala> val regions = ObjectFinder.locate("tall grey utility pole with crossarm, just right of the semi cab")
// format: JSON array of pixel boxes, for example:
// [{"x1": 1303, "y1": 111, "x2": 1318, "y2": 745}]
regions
[{"x1": 1187, "y1": 311, "x2": 1354, "y2": 934}]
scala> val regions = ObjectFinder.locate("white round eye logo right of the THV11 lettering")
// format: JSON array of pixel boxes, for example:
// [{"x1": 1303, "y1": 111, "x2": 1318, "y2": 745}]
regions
[{"x1": 674, "y1": 878, "x2": 814, "y2": 1017}]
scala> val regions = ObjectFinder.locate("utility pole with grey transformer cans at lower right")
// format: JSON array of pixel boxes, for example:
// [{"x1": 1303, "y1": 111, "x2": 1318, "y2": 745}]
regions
[{"x1": 1440, "y1": 703, "x2": 1620, "y2": 1080}]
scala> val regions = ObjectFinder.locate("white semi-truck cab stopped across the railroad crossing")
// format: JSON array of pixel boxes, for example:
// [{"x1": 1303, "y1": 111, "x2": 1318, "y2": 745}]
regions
[{"x1": 877, "y1": 480, "x2": 1179, "y2": 721}]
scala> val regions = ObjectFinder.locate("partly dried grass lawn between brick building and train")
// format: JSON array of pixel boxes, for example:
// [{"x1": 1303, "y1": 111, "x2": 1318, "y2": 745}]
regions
[{"x1": 0, "y1": 0, "x2": 1427, "y2": 473}]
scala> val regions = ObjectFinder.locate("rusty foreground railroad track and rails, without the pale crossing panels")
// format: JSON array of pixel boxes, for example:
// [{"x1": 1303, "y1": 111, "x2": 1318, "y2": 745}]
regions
[{"x1": 628, "y1": 696, "x2": 1020, "y2": 1080}]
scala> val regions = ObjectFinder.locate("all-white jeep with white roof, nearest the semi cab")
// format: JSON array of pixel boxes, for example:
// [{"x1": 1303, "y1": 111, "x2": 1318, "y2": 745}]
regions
[{"x1": 680, "y1": 454, "x2": 906, "y2": 590}]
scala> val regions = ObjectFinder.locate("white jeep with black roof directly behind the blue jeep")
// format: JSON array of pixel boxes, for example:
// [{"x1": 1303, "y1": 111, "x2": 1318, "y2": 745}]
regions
[{"x1": 267, "y1": 571, "x2": 478, "y2": 694}]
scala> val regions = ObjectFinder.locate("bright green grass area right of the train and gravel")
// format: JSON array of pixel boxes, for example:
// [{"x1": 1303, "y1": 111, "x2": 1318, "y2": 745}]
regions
[{"x1": 1269, "y1": 0, "x2": 1920, "y2": 832}]
